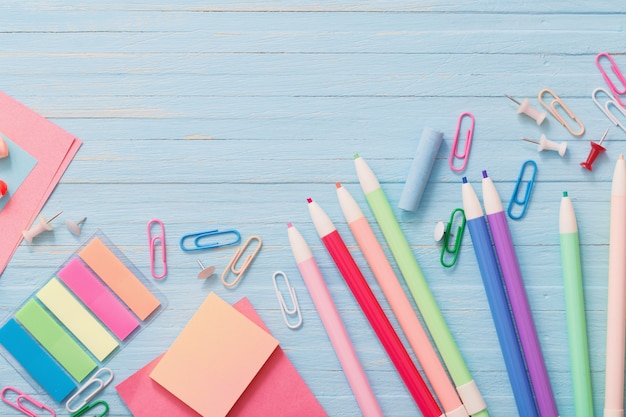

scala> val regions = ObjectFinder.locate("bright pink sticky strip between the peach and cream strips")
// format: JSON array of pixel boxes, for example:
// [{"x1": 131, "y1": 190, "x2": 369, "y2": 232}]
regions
[{"x1": 57, "y1": 258, "x2": 139, "y2": 340}]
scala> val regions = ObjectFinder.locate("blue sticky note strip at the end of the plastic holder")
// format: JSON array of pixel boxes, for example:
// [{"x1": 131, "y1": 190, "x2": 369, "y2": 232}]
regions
[{"x1": 0, "y1": 318, "x2": 76, "y2": 402}]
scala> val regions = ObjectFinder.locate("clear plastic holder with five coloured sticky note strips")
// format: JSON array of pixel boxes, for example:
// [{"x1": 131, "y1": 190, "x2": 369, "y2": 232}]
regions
[{"x1": 0, "y1": 231, "x2": 167, "y2": 403}]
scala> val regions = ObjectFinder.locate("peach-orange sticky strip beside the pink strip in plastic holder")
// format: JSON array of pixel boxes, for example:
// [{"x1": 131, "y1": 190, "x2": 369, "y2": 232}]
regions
[{"x1": 78, "y1": 237, "x2": 161, "y2": 320}]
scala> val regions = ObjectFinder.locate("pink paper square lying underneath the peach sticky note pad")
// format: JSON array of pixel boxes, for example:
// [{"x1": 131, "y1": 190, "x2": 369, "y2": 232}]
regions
[{"x1": 115, "y1": 298, "x2": 327, "y2": 417}]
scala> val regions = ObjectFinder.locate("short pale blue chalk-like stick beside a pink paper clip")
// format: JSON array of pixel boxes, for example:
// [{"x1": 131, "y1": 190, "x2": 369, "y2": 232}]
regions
[{"x1": 398, "y1": 127, "x2": 443, "y2": 211}]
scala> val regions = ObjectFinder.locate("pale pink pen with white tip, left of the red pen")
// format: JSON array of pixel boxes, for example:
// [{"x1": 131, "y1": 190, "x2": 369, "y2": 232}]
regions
[{"x1": 287, "y1": 223, "x2": 383, "y2": 417}]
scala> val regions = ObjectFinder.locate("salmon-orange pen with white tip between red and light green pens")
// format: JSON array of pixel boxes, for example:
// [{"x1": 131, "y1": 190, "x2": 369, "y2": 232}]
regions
[{"x1": 337, "y1": 183, "x2": 467, "y2": 417}]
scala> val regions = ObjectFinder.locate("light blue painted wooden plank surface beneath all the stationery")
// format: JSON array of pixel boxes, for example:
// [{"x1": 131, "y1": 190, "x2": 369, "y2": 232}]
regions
[{"x1": 0, "y1": 0, "x2": 626, "y2": 417}]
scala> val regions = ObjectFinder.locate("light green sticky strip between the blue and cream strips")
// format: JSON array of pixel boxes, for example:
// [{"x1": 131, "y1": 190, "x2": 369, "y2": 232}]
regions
[{"x1": 15, "y1": 298, "x2": 97, "y2": 382}]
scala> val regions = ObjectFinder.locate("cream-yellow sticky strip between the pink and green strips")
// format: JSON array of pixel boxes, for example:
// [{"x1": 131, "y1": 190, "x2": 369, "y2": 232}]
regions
[{"x1": 37, "y1": 278, "x2": 118, "y2": 361}]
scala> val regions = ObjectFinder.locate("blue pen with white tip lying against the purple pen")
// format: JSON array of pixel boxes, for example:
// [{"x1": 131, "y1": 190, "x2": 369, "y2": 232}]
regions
[{"x1": 462, "y1": 177, "x2": 538, "y2": 417}]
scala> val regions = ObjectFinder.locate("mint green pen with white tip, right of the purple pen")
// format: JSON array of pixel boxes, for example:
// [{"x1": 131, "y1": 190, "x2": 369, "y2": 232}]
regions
[{"x1": 559, "y1": 191, "x2": 593, "y2": 416}]
